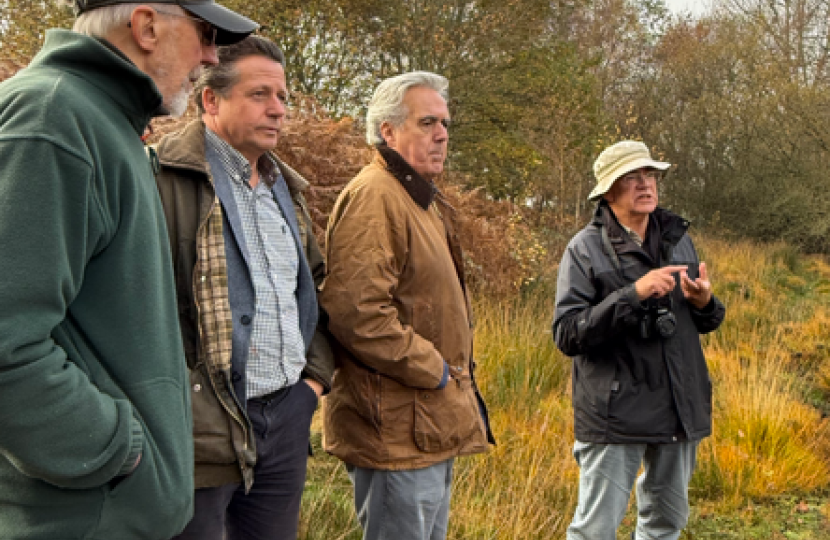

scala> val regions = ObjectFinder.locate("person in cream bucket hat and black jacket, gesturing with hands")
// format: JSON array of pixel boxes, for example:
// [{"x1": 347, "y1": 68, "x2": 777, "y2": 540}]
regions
[{"x1": 553, "y1": 141, "x2": 725, "y2": 540}]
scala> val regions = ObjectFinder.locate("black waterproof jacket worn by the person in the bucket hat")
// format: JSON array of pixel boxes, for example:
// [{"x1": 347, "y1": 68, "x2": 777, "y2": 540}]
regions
[{"x1": 553, "y1": 201, "x2": 726, "y2": 443}]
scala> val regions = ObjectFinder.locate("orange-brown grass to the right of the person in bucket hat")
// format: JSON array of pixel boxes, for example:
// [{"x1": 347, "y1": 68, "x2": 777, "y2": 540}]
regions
[{"x1": 693, "y1": 240, "x2": 830, "y2": 507}]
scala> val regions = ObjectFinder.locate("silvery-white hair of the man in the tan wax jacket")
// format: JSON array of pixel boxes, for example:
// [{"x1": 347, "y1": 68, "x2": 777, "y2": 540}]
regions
[{"x1": 366, "y1": 71, "x2": 450, "y2": 145}]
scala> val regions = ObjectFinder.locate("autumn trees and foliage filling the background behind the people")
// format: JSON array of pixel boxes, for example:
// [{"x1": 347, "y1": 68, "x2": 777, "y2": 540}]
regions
[{"x1": 0, "y1": 0, "x2": 830, "y2": 251}]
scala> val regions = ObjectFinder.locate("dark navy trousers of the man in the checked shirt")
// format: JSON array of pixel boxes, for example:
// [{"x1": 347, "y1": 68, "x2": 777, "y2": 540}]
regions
[{"x1": 174, "y1": 381, "x2": 317, "y2": 540}]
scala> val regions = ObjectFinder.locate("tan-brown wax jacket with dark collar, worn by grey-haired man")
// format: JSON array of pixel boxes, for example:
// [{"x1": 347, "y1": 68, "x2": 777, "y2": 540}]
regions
[{"x1": 320, "y1": 148, "x2": 492, "y2": 470}]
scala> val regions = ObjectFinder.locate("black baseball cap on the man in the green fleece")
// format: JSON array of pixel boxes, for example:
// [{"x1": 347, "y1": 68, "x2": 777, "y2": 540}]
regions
[{"x1": 75, "y1": 0, "x2": 259, "y2": 45}]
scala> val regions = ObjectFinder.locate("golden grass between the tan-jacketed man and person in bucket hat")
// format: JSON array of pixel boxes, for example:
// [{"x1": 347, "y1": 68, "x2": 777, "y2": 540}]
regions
[{"x1": 450, "y1": 295, "x2": 578, "y2": 540}]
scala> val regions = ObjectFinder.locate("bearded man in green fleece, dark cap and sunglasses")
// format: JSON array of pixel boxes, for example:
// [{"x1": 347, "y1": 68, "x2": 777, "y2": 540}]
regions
[{"x1": 0, "y1": 0, "x2": 256, "y2": 540}]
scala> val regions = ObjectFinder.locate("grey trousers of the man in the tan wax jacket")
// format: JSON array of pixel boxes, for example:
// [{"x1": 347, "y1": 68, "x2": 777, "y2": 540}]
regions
[{"x1": 346, "y1": 459, "x2": 453, "y2": 540}]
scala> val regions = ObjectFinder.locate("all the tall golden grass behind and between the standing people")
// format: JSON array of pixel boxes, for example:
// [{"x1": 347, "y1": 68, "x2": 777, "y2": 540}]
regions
[{"x1": 300, "y1": 239, "x2": 830, "y2": 540}]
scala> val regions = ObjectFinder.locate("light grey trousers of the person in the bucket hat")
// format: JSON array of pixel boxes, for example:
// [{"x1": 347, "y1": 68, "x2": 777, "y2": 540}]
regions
[{"x1": 567, "y1": 441, "x2": 698, "y2": 540}]
